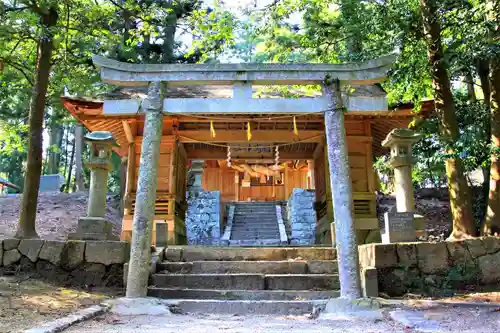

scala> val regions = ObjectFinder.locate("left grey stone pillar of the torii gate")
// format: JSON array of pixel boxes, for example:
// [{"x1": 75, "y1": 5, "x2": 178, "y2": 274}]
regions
[{"x1": 126, "y1": 82, "x2": 163, "y2": 297}]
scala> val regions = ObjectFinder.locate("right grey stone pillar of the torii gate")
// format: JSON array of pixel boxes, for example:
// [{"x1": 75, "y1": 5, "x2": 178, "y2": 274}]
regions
[{"x1": 323, "y1": 80, "x2": 361, "y2": 299}]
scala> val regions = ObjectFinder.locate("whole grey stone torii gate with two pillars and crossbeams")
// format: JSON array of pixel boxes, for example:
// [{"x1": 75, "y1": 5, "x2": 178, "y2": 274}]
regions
[{"x1": 93, "y1": 55, "x2": 395, "y2": 299}]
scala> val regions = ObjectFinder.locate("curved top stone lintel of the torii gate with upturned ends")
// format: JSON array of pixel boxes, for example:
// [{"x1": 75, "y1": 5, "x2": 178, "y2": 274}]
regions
[{"x1": 92, "y1": 54, "x2": 396, "y2": 86}]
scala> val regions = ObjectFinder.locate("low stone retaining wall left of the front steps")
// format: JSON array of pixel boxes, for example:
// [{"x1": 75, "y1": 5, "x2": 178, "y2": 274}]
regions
[{"x1": 0, "y1": 238, "x2": 130, "y2": 287}]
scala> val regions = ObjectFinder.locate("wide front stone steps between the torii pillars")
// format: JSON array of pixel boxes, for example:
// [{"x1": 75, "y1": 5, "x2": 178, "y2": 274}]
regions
[{"x1": 148, "y1": 247, "x2": 339, "y2": 315}]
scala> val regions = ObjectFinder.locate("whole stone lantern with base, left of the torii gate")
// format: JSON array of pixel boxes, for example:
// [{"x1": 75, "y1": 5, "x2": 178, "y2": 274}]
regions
[{"x1": 71, "y1": 131, "x2": 117, "y2": 240}]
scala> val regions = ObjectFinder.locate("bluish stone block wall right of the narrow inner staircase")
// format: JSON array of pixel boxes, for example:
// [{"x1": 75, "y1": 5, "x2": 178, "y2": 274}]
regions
[{"x1": 287, "y1": 188, "x2": 316, "y2": 245}]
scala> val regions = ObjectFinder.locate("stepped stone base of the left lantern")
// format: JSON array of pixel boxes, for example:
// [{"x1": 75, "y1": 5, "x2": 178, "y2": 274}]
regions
[{"x1": 68, "y1": 217, "x2": 119, "y2": 240}]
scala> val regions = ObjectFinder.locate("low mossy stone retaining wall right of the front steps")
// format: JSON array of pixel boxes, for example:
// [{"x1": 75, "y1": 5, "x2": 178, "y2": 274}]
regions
[{"x1": 359, "y1": 237, "x2": 500, "y2": 296}]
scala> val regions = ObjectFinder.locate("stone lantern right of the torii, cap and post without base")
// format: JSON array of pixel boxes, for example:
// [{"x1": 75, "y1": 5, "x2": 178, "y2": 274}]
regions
[{"x1": 382, "y1": 128, "x2": 420, "y2": 213}]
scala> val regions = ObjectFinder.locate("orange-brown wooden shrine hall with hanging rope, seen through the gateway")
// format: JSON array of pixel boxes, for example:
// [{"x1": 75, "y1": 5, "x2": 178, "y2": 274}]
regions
[{"x1": 184, "y1": 142, "x2": 317, "y2": 202}]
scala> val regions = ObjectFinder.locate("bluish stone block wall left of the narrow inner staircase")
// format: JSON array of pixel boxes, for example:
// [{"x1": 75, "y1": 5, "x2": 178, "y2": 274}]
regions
[{"x1": 186, "y1": 191, "x2": 222, "y2": 245}]
